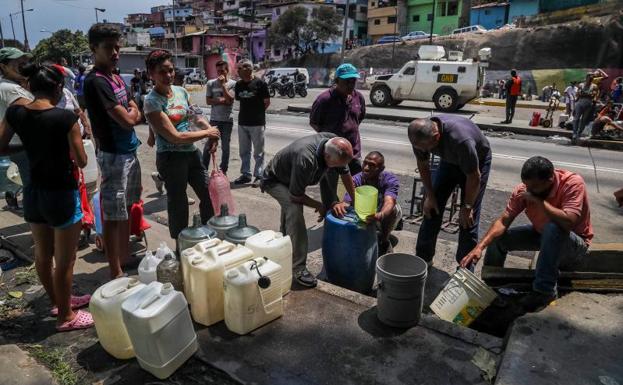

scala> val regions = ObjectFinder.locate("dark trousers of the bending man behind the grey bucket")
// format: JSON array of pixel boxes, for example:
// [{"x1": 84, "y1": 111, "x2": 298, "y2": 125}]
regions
[{"x1": 415, "y1": 154, "x2": 491, "y2": 262}]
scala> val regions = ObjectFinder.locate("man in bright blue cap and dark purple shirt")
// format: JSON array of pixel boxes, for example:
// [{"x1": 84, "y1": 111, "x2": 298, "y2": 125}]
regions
[{"x1": 309, "y1": 63, "x2": 366, "y2": 216}]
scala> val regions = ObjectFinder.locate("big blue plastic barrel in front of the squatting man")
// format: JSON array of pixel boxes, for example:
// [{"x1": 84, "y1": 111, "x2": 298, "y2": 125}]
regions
[{"x1": 322, "y1": 210, "x2": 379, "y2": 294}]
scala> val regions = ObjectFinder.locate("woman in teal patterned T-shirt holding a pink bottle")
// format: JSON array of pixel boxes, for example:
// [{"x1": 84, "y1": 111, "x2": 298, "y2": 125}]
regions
[{"x1": 144, "y1": 50, "x2": 219, "y2": 251}]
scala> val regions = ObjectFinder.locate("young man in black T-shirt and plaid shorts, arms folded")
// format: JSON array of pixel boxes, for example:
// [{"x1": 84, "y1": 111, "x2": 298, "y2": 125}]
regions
[{"x1": 84, "y1": 23, "x2": 143, "y2": 279}]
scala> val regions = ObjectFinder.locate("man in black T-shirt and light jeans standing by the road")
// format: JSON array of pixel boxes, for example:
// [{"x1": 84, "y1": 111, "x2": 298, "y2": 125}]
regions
[{"x1": 234, "y1": 60, "x2": 270, "y2": 187}]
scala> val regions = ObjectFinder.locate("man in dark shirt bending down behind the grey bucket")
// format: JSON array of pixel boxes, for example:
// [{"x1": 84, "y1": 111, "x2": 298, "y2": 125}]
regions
[{"x1": 408, "y1": 115, "x2": 491, "y2": 269}]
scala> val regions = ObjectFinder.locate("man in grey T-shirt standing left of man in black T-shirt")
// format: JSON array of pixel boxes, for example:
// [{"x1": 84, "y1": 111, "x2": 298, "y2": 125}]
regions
[{"x1": 203, "y1": 60, "x2": 236, "y2": 174}]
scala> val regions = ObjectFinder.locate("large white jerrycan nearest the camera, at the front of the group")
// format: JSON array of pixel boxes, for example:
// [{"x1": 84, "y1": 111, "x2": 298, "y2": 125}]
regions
[{"x1": 121, "y1": 282, "x2": 197, "y2": 379}]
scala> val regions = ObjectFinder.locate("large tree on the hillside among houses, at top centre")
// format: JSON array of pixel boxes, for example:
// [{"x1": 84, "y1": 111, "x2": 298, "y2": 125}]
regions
[{"x1": 269, "y1": 6, "x2": 342, "y2": 55}]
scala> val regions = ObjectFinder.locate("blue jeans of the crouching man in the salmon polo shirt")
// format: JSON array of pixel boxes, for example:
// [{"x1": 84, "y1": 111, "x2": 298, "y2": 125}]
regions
[{"x1": 485, "y1": 222, "x2": 588, "y2": 294}]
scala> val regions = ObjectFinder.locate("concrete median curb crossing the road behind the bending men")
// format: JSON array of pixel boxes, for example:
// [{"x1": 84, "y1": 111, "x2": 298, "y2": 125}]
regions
[{"x1": 288, "y1": 105, "x2": 623, "y2": 151}]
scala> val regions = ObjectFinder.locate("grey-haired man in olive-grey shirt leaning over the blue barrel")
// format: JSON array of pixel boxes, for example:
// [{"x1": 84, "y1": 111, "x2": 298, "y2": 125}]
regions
[{"x1": 261, "y1": 132, "x2": 355, "y2": 287}]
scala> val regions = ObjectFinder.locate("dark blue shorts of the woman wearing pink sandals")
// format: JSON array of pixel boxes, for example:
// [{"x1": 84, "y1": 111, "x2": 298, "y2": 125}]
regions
[{"x1": 23, "y1": 186, "x2": 82, "y2": 229}]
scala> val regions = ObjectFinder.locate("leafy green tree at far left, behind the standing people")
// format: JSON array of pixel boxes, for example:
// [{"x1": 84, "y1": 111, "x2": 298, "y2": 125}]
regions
[{"x1": 32, "y1": 29, "x2": 89, "y2": 63}]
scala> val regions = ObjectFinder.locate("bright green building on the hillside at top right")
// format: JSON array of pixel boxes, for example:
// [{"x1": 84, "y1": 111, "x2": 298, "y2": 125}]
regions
[{"x1": 407, "y1": 0, "x2": 470, "y2": 35}]
